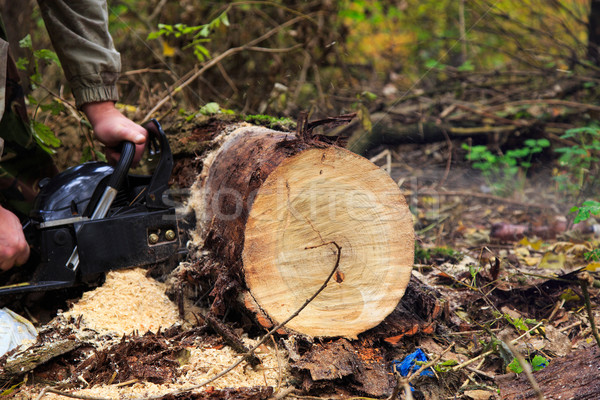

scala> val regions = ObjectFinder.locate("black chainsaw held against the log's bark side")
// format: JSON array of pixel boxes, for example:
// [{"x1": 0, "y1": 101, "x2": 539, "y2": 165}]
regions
[{"x1": 0, "y1": 120, "x2": 186, "y2": 296}]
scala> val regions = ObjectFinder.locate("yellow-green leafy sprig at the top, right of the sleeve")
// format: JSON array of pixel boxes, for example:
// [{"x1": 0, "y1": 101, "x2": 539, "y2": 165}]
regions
[{"x1": 148, "y1": 8, "x2": 229, "y2": 62}]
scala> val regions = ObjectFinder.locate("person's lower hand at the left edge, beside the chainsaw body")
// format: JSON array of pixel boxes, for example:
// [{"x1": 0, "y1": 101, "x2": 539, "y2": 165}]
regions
[{"x1": 0, "y1": 206, "x2": 29, "y2": 271}]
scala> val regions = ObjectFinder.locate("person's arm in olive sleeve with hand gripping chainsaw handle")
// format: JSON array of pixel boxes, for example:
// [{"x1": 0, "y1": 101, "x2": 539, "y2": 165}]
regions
[{"x1": 38, "y1": 0, "x2": 147, "y2": 162}]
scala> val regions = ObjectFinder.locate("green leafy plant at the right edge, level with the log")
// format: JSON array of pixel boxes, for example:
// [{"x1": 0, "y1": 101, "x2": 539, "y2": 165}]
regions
[{"x1": 554, "y1": 122, "x2": 600, "y2": 192}]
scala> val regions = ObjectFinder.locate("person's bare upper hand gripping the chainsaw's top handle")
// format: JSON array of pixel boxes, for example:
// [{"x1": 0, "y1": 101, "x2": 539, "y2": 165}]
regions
[{"x1": 81, "y1": 101, "x2": 148, "y2": 165}]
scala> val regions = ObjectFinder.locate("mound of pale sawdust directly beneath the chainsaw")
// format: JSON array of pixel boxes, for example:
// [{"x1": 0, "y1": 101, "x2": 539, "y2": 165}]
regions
[{"x1": 63, "y1": 268, "x2": 182, "y2": 335}]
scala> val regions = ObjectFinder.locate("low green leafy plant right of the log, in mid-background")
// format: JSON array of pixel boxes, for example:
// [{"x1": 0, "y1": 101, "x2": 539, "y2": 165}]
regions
[{"x1": 462, "y1": 139, "x2": 550, "y2": 195}]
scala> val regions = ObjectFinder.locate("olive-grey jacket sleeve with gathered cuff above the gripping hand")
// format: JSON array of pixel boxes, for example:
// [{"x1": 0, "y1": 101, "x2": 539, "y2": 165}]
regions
[{"x1": 38, "y1": 0, "x2": 121, "y2": 107}]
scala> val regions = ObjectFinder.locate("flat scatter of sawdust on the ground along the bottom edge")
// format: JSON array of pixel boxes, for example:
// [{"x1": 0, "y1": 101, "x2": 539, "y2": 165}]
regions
[{"x1": 33, "y1": 338, "x2": 290, "y2": 400}]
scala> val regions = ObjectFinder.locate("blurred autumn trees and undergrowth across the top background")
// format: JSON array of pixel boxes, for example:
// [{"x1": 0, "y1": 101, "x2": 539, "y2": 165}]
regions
[{"x1": 0, "y1": 0, "x2": 600, "y2": 119}]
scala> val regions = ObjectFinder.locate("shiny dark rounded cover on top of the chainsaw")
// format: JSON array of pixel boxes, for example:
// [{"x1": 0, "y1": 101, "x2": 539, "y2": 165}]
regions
[{"x1": 31, "y1": 161, "x2": 113, "y2": 223}]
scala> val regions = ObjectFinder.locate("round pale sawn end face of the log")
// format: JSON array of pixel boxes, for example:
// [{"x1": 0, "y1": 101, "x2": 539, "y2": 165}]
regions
[{"x1": 242, "y1": 146, "x2": 414, "y2": 338}]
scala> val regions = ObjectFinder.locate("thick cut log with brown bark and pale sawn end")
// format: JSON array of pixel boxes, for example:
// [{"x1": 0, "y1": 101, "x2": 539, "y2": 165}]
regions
[{"x1": 192, "y1": 126, "x2": 414, "y2": 338}]
